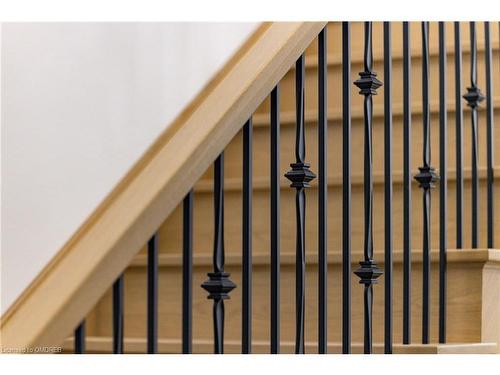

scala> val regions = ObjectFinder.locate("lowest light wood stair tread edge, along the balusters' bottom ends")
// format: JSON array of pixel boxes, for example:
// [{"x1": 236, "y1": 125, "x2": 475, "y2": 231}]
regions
[{"x1": 63, "y1": 336, "x2": 497, "y2": 354}]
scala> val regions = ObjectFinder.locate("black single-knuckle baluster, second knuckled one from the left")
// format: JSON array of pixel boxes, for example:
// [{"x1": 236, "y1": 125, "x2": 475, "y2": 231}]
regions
[{"x1": 285, "y1": 55, "x2": 316, "y2": 354}]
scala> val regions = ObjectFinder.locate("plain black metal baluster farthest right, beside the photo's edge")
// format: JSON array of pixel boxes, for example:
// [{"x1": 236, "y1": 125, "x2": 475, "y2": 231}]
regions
[{"x1": 484, "y1": 22, "x2": 495, "y2": 249}]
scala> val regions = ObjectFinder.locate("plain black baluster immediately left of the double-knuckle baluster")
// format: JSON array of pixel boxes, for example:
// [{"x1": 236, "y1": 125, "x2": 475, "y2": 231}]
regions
[{"x1": 342, "y1": 22, "x2": 352, "y2": 354}]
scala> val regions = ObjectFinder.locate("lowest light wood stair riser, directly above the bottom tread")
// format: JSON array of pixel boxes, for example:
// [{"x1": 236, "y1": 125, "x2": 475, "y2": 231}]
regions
[{"x1": 88, "y1": 250, "x2": 484, "y2": 343}]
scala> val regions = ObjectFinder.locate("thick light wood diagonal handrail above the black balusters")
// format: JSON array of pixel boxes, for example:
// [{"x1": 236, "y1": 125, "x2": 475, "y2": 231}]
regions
[{"x1": 0, "y1": 22, "x2": 326, "y2": 348}]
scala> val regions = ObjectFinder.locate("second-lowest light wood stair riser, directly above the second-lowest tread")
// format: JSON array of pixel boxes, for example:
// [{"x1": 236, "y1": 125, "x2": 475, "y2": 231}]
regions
[{"x1": 149, "y1": 173, "x2": 500, "y2": 254}]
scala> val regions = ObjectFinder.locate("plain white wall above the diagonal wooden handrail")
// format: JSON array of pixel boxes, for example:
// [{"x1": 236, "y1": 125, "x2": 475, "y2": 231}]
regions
[{"x1": 1, "y1": 23, "x2": 257, "y2": 313}]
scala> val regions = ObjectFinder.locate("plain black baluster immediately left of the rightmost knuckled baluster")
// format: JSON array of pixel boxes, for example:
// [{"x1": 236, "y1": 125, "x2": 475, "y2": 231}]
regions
[{"x1": 454, "y1": 22, "x2": 464, "y2": 249}]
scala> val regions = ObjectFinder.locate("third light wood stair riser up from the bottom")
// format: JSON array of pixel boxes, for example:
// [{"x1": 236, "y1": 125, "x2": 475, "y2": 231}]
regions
[{"x1": 198, "y1": 108, "x2": 500, "y2": 185}]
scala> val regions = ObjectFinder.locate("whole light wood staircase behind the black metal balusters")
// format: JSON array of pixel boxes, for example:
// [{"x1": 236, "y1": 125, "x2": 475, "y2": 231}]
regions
[{"x1": 77, "y1": 23, "x2": 500, "y2": 353}]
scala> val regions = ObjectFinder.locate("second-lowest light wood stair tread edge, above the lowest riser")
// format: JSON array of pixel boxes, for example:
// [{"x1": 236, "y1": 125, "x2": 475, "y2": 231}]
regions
[{"x1": 130, "y1": 249, "x2": 491, "y2": 268}]
